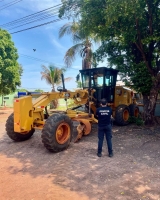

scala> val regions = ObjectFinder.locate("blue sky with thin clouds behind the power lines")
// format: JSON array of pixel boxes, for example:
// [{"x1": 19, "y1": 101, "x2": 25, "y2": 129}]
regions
[{"x1": 0, "y1": 0, "x2": 82, "y2": 91}]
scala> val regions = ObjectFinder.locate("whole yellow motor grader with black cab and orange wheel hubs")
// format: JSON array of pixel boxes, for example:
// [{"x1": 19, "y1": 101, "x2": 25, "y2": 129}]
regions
[{"x1": 6, "y1": 67, "x2": 139, "y2": 152}]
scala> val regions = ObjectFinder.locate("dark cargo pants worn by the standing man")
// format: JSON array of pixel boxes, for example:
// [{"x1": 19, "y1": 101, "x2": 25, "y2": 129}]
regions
[{"x1": 98, "y1": 124, "x2": 112, "y2": 154}]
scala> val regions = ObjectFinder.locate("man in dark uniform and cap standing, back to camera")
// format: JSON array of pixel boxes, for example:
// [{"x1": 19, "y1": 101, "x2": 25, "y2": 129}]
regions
[{"x1": 96, "y1": 99, "x2": 113, "y2": 157}]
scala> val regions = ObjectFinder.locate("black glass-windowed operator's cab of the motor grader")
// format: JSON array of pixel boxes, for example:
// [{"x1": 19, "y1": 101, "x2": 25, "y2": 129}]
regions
[{"x1": 80, "y1": 67, "x2": 118, "y2": 107}]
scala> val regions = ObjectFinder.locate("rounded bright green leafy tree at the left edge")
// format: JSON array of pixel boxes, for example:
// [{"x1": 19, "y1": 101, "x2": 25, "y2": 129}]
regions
[{"x1": 0, "y1": 29, "x2": 23, "y2": 95}]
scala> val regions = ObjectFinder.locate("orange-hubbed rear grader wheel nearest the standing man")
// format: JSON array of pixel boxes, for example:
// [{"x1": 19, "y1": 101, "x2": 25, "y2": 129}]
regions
[{"x1": 115, "y1": 104, "x2": 130, "y2": 126}]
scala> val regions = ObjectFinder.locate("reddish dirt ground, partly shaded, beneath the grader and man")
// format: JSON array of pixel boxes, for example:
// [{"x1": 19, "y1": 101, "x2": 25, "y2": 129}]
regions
[{"x1": 0, "y1": 110, "x2": 160, "y2": 200}]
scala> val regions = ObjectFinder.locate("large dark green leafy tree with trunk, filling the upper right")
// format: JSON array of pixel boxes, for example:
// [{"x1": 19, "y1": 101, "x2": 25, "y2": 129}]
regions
[{"x1": 60, "y1": 0, "x2": 160, "y2": 124}]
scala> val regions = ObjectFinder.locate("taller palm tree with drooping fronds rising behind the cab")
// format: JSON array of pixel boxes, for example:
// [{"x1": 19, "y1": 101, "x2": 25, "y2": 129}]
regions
[{"x1": 59, "y1": 22, "x2": 99, "y2": 69}]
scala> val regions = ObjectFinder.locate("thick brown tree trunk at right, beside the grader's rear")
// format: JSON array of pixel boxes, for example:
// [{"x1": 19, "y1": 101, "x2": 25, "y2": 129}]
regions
[{"x1": 143, "y1": 80, "x2": 158, "y2": 126}]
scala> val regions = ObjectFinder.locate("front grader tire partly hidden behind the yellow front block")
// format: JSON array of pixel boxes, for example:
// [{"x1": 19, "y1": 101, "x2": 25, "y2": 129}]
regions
[{"x1": 6, "y1": 113, "x2": 35, "y2": 142}]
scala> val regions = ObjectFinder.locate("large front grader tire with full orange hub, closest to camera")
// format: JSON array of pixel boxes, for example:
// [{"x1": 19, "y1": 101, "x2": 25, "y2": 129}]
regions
[{"x1": 42, "y1": 113, "x2": 73, "y2": 152}]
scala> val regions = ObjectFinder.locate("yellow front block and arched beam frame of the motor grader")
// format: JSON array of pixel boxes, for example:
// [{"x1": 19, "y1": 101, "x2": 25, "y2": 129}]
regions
[{"x1": 14, "y1": 90, "x2": 96, "y2": 134}]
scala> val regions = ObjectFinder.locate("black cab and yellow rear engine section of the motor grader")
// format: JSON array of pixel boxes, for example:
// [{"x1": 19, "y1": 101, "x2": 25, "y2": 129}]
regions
[{"x1": 80, "y1": 67, "x2": 139, "y2": 126}]
